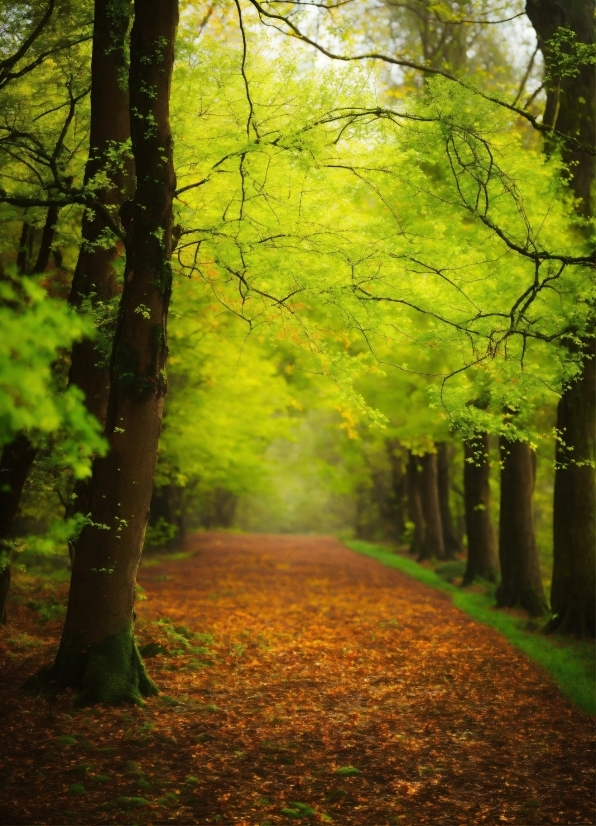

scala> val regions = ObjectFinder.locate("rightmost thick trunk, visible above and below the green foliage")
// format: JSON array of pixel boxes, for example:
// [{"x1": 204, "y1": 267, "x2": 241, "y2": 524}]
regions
[{"x1": 526, "y1": 0, "x2": 596, "y2": 636}]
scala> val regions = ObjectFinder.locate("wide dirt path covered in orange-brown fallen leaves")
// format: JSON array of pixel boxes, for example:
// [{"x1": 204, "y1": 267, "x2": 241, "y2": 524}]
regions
[{"x1": 0, "y1": 533, "x2": 596, "y2": 826}]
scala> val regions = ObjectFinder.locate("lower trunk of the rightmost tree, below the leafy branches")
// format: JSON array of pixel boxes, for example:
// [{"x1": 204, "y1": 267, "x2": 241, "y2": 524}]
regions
[{"x1": 548, "y1": 342, "x2": 596, "y2": 636}]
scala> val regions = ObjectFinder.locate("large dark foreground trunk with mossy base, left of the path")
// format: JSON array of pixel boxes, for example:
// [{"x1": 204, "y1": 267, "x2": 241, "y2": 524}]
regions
[{"x1": 50, "y1": 0, "x2": 178, "y2": 704}]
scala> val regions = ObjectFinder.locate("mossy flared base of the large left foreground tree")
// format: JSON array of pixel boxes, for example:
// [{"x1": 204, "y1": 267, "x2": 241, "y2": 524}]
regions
[{"x1": 24, "y1": 624, "x2": 157, "y2": 706}]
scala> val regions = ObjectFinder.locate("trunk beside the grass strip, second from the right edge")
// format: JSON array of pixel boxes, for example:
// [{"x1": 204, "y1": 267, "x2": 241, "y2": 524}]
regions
[{"x1": 497, "y1": 437, "x2": 548, "y2": 617}]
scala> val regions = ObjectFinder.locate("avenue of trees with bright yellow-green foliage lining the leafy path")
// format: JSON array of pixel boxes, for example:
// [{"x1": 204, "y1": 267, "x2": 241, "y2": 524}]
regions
[{"x1": 0, "y1": 0, "x2": 596, "y2": 703}]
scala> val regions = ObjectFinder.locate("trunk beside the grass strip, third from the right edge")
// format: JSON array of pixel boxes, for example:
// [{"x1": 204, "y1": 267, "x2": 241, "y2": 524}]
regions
[{"x1": 463, "y1": 433, "x2": 498, "y2": 585}]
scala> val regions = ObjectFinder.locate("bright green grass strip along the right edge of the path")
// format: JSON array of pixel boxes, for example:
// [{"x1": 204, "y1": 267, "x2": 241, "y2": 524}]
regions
[{"x1": 344, "y1": 540, "x2": 596, "y2": 715}]
